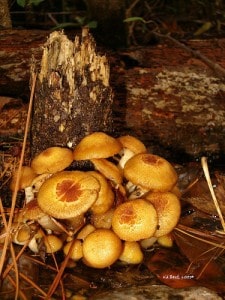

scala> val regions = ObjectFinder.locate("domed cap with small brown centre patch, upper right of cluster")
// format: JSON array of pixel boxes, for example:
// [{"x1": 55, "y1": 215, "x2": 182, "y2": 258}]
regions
[{"x1": 124, "y1": 153, "x2": 178, "y2": 192}]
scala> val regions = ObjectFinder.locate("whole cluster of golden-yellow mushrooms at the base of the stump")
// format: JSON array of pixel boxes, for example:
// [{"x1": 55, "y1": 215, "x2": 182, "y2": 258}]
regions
[{"x1": 8, "y1": 132, "x2": 181, "y2": 268}]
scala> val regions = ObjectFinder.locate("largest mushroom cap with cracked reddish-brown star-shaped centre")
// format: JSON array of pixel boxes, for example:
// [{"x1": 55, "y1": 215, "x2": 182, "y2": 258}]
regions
[{"x1": 37, "y1": 171, "x2": 100, "y2": 219}]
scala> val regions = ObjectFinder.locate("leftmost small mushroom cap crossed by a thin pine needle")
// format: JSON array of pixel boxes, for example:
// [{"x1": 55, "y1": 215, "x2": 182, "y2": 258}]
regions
[{"x1": 10, "y1": 166, "x2": 37, "y2": 191}]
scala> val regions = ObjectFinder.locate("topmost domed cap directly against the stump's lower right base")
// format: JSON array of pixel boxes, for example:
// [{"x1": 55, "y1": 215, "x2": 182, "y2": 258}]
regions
[{"x1": 73, "y1": 132, "x2": 122, "y2": 160}]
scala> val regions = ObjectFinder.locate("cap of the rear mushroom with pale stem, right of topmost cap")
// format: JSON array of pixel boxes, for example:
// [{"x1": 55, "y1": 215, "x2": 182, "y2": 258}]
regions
[{"x1": 117, "y1": 135, "x2": 147, "y2": 154}]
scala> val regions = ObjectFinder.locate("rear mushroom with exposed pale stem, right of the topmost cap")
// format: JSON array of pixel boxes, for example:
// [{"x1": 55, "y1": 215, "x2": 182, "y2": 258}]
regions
[{"x1": 117, "y1": 135, "x2": 147, "y2": 169}]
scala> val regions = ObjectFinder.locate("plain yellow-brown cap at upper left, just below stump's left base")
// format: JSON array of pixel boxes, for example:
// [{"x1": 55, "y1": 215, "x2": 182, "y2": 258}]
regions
[{"x1": 31, "y1": 147, "x2": 73, "y2": 174}]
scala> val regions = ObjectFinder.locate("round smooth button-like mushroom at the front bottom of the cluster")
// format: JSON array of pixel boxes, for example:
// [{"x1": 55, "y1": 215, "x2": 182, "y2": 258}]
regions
[{"x1": 83, "y1": 229, "x2": 123, "y2": 268}]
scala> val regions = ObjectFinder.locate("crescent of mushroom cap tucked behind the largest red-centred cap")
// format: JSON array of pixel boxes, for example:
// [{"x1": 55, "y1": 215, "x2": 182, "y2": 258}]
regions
[{"x1": 87, "y1": 171, "x2": 114, "y2": 214}]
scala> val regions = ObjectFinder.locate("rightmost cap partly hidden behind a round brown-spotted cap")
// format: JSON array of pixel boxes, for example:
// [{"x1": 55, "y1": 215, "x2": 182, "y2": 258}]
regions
[{"x1": 145, "y1": 192, "x2": 181, "y2": 238}]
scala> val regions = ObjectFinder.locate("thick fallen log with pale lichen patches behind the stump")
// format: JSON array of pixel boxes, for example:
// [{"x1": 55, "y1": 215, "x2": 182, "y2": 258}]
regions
[{"x1": 0, "y1": 30, "x2": 225, "y2": 161}]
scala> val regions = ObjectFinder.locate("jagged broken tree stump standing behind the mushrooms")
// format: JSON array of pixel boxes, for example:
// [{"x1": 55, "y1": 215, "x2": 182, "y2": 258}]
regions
[{"x1": 30, "y1": 28, "x2": 113, "y2": 157}]
